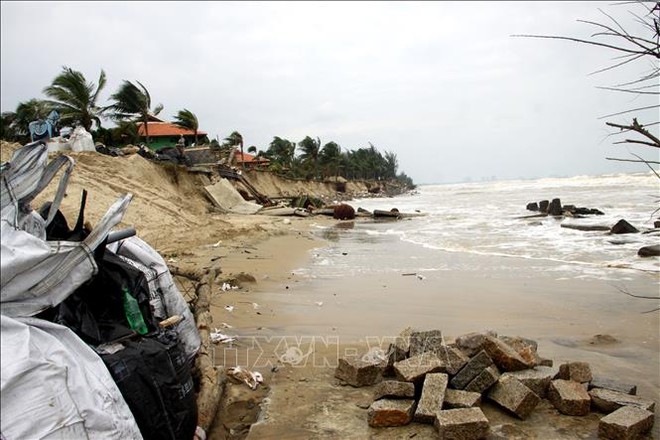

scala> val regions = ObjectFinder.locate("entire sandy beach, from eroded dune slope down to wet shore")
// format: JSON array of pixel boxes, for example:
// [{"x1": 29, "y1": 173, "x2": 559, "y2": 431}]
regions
[{"x1": 2, "y1": 144, "x2": 660, "y2": 439}]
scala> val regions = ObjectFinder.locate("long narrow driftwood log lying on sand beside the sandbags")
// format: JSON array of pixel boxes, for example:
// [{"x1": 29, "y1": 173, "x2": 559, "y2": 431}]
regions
[{"x1": 194, "y1": 268, "x2": 227, "y2": 432}]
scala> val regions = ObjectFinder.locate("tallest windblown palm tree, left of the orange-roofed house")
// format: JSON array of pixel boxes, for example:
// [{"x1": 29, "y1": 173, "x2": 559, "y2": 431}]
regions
[{"x1": 43, "y1": 66, "x2": 106, "y2": 131}]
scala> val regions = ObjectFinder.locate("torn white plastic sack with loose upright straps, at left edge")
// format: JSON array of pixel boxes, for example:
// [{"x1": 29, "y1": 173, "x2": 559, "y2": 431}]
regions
[{"x1": 0, "y1": 143, "x2": 132, "y2": 317}]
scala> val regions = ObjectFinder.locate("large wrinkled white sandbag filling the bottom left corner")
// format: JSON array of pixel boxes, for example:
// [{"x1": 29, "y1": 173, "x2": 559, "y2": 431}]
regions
[{"x1": 0, "y1": 315, "x2": 142, "y2": 440}]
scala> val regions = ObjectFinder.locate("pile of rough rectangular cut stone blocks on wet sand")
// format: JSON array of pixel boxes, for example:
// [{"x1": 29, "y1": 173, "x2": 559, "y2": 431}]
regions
[{"x1": 335, "y1": 328, "x2": 655, "y2": 440}]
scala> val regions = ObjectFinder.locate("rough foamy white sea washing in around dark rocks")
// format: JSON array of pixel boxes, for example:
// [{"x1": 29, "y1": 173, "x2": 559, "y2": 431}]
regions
[{"x1": 296, "y1": 172, "x2": 660, "y2": 284}]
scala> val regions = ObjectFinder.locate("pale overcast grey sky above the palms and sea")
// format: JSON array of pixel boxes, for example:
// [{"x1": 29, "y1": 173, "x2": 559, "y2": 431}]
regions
[{"x1": 0, "y1": 1, "x2": 660, "y2": 183}]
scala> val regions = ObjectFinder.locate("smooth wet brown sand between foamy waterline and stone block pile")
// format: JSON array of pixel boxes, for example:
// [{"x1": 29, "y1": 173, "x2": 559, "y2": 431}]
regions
[{"x1": 204, "y1": 223, "x2": 660, "y2": 438}]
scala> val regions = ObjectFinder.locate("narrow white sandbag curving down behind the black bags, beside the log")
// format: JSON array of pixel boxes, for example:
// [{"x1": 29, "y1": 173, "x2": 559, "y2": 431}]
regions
[{"x1": 107, "y1": 236, "x2": 201, "y2": 359}]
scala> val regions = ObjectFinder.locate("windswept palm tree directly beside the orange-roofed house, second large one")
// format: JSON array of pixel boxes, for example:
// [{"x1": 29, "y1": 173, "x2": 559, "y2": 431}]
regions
[{"x1": 106, "y1": 80, "x2": 163, "y2": 145}]
